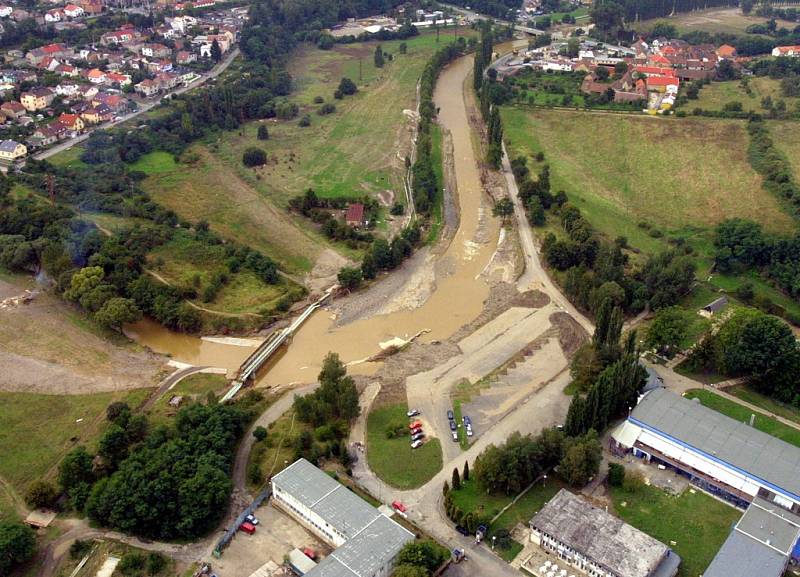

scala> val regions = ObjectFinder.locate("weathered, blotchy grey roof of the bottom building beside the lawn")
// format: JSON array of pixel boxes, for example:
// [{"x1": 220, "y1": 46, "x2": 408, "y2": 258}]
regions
[{"x1": 531, "y1": 489, "x2": 675, "y2": 577}]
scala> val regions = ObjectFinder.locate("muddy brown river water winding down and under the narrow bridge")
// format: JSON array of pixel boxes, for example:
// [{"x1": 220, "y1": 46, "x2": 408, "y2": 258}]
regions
[{"x1": 128, "y1": 51, "x2": 506, "y2": 386}]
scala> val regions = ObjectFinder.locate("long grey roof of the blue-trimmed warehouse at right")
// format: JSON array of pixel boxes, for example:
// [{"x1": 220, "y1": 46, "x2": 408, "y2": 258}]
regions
[{"x1": 630, "y1": 389, "x2": 800, "y2": 499}]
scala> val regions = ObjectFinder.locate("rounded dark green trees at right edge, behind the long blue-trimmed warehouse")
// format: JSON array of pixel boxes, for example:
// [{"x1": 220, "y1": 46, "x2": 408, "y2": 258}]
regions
[{"x1": 689, "y1": 308, "x2": 800, "y2": 406}]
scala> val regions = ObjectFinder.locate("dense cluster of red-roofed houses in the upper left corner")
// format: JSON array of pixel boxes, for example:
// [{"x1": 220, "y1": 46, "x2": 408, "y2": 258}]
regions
[{"x1": 0, "y1": 0, "x2": 247, "y2": 169}]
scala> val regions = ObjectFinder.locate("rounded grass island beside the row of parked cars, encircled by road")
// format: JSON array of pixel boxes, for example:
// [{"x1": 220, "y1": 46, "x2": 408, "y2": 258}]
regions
[{"x1": 367, "y1": 404, "x2": 442, "y2": 489}]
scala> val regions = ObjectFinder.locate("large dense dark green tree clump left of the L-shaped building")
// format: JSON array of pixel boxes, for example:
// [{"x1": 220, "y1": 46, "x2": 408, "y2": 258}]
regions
[{"x1": 81, "y1": 398, "x2": 253, "y2": 539}]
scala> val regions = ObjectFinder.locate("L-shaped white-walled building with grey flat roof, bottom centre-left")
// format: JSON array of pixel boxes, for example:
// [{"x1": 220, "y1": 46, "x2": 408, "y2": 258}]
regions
[{"x1": 272, "y1": 459, "x2": 414, "y2": 577}]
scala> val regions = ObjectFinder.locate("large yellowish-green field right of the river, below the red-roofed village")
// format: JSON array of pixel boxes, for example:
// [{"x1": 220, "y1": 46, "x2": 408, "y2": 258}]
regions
[{"x1": 503, "y1": 108, "x2": 795, "y2": 253}]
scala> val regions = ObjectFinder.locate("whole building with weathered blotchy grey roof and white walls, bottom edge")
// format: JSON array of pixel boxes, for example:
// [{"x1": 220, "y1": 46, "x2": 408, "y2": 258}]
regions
[{"x1": 530, "y1": 489, "x2": 681, "y2": 577}]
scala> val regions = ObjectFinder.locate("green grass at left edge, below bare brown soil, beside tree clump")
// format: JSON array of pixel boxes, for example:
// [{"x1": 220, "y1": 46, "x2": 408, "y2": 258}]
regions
[{"x1": 0, "y1": 389, "x2": 152, "y2": 492}]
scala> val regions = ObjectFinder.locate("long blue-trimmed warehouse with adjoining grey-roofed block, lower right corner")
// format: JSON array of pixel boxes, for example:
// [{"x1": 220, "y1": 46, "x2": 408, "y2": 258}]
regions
[{"x1": 612, "y1": 389, "x2": 800, "y2": 577}]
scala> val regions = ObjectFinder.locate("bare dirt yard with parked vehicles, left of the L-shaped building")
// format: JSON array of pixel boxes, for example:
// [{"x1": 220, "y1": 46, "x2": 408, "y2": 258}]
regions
[{"x1": 207, "y1": 503, "x2": 330, "y2": 577}]
